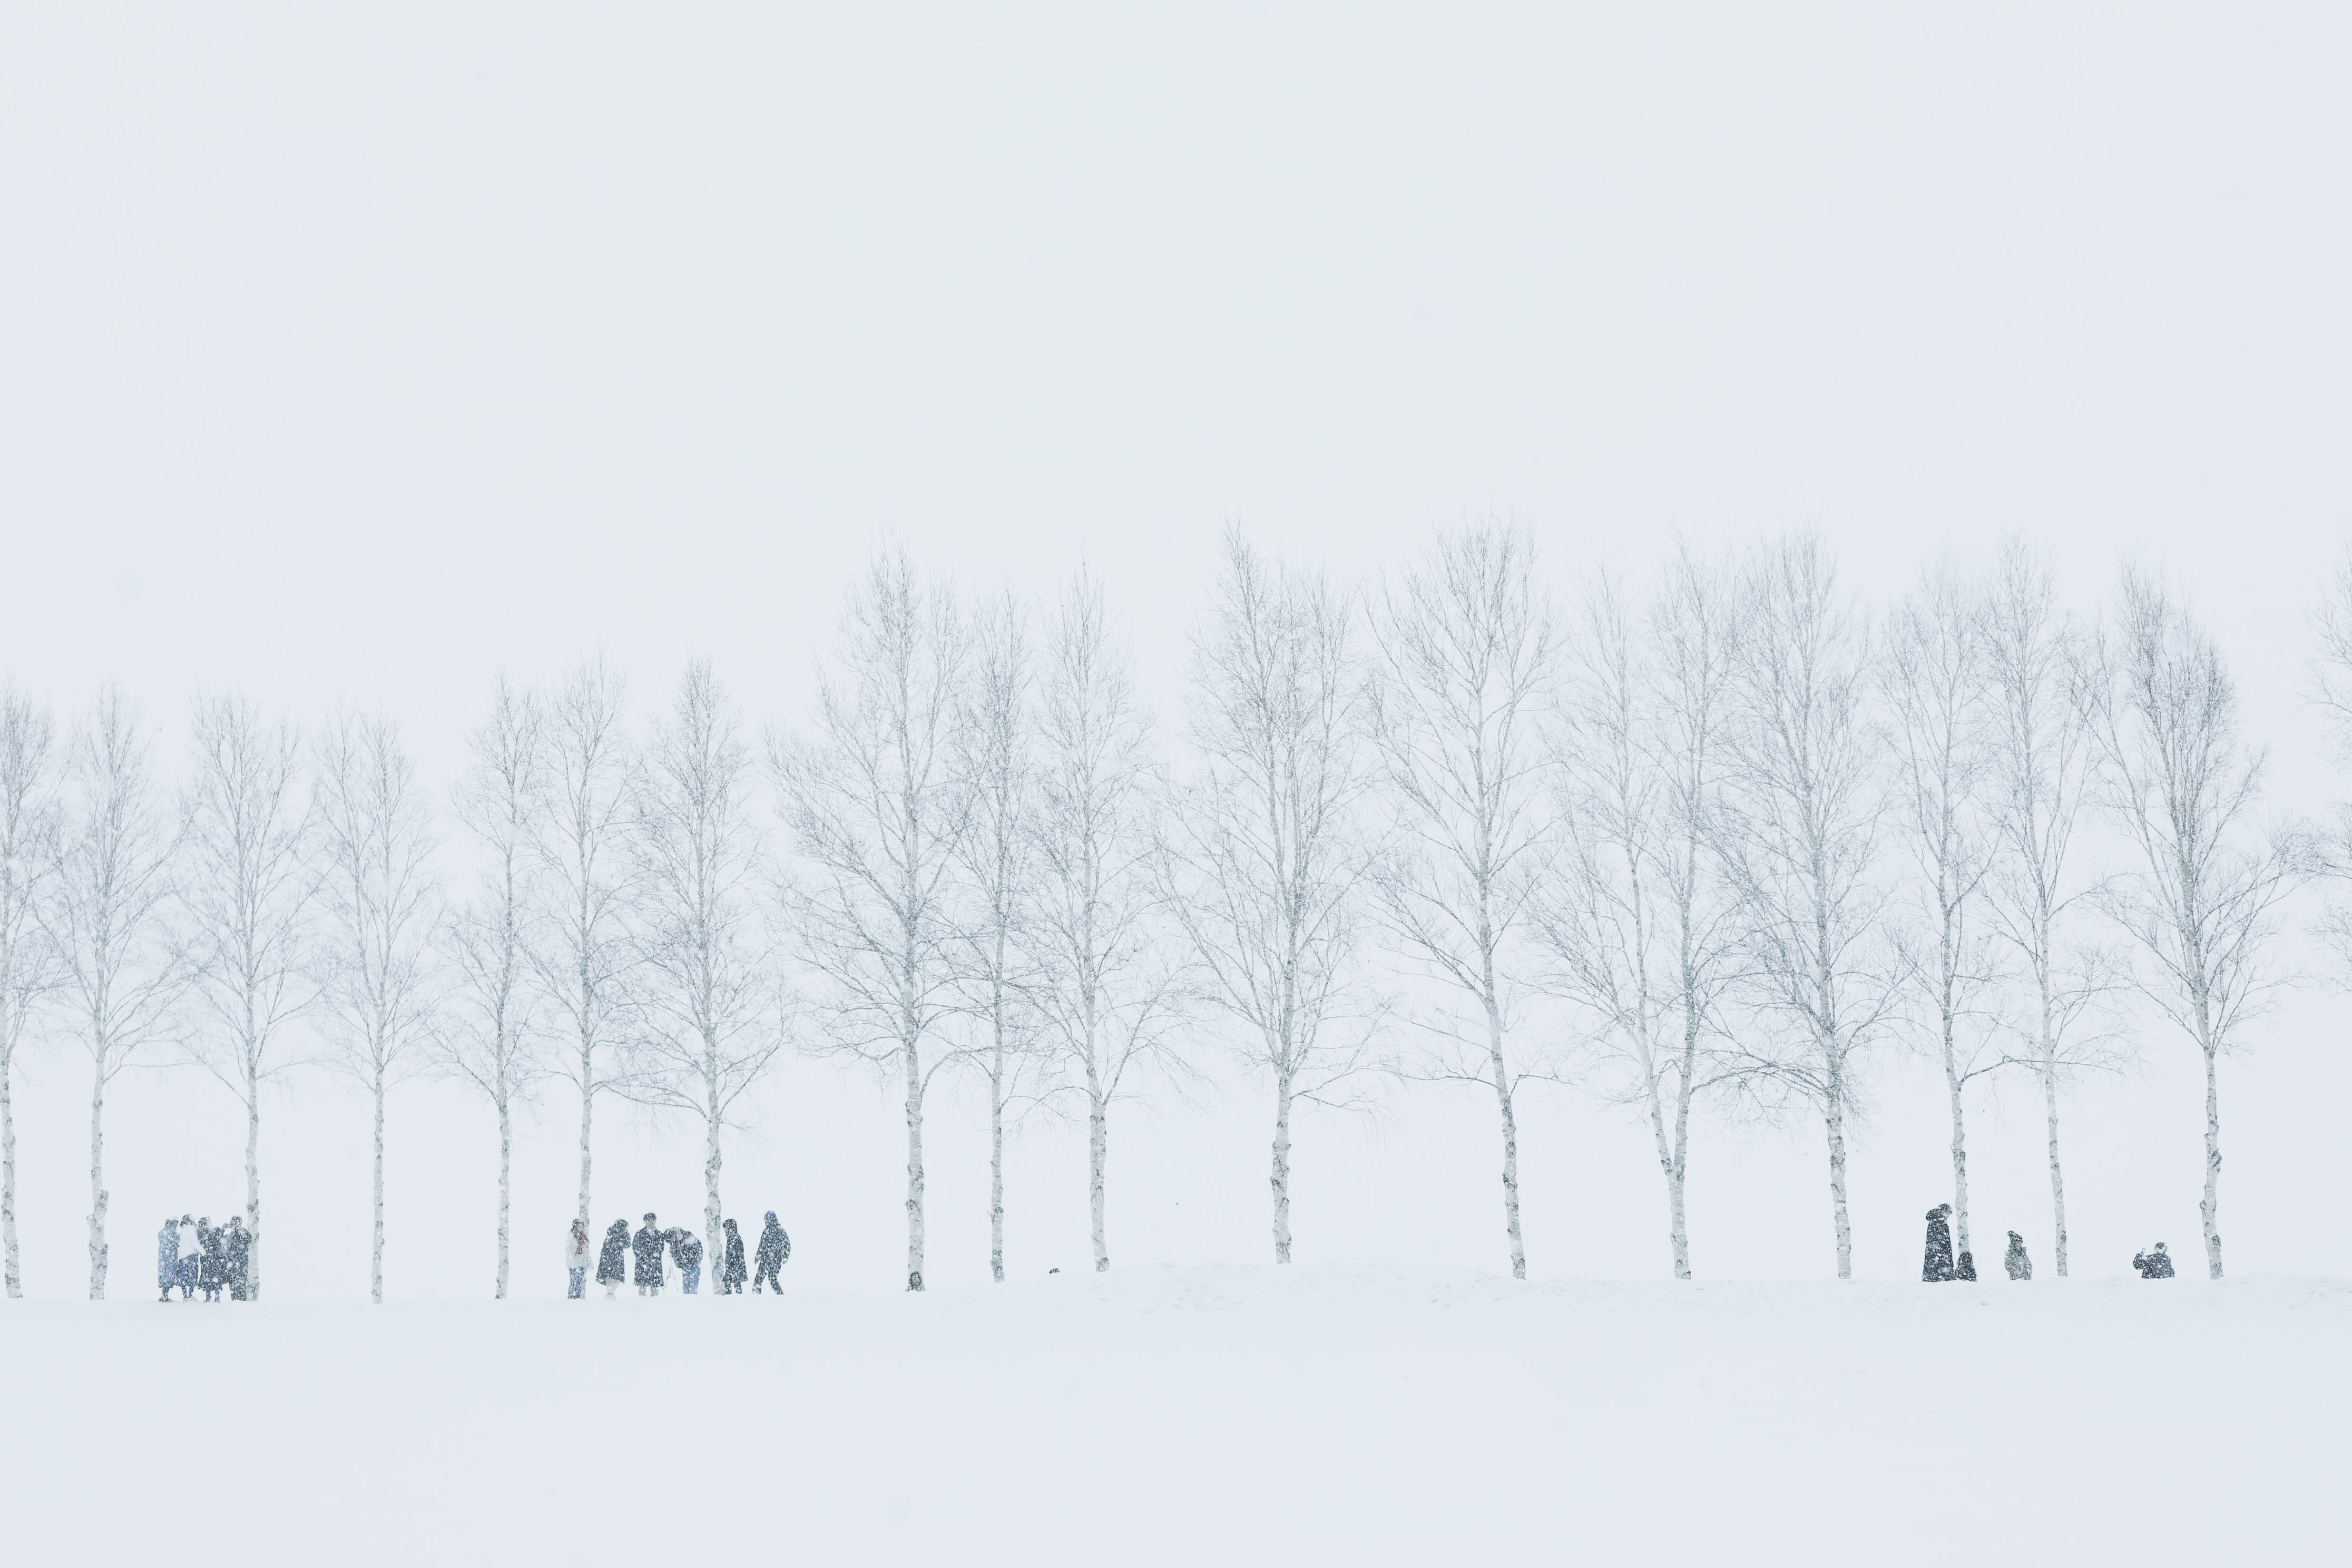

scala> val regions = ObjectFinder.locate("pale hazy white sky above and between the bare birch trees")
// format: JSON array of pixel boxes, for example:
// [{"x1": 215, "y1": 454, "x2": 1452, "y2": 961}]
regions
[{"x1": 0, "y1": 0, "x2": 2352, "y2": 1300}]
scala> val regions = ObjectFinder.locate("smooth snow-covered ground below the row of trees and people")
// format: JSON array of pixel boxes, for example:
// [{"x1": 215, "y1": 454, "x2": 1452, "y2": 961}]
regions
[{"x1": 0, "y1": 1267, "x2": 2352, "y2": 1566}]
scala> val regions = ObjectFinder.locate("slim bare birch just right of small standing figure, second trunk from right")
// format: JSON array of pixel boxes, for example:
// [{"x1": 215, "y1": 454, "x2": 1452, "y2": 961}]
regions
[{"x1": 1985, "y1": 538, "x2": 2105, "y2": 1279}]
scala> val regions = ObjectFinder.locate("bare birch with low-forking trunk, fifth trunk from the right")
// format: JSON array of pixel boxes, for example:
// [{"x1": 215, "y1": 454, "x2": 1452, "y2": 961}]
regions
[{"x1": 1538, "y1": 548, "x2": 1740, "y2": 1279}]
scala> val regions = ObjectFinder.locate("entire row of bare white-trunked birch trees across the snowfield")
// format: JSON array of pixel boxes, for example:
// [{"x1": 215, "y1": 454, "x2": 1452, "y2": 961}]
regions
[{"x1": 0, "y1": 522, "x2": 2324, "y2": 1300}]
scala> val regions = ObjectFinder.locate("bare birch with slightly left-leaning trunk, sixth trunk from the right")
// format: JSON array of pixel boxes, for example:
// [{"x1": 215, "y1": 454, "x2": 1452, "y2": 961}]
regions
[{"x1": 1369, "y1": 520, "x2": 1557, "y2": 1279}]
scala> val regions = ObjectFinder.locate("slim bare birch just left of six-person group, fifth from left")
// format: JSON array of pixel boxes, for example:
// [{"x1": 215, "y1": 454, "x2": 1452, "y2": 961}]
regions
[{"x1": 433, "y1": 675, "x2": 548, "y2": 1300}]
